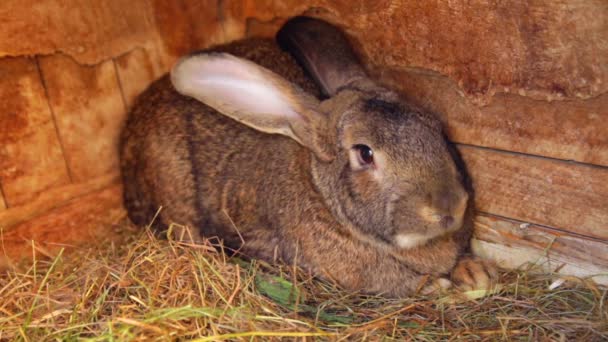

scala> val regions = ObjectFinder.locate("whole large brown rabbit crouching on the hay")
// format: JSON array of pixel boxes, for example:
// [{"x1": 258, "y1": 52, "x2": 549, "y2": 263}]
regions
[{"x1": 121, "y1": 17, "x2": 494, "y2": 296}]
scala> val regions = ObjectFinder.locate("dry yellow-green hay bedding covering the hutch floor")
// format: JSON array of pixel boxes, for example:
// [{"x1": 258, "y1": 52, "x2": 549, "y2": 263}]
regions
[{"x1": 0, "y1": 220, "x2": 608, "y2": 341}]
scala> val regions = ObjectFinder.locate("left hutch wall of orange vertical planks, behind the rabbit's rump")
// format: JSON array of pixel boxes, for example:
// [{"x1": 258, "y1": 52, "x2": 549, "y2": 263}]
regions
[{"x1": 0, "y1": 0, "x2": 167, "y2": 256}]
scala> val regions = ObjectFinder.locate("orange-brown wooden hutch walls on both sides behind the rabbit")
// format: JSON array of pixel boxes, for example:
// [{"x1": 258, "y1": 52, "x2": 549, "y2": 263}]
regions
[{"x1": 0, "y1": 0, "x2": 608, "y2": 282}]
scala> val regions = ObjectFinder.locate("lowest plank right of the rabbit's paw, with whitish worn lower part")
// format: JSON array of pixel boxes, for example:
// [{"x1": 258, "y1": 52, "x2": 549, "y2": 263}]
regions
[{"x1": 472, "y1": 215, "x2": 608, "y2": 284}]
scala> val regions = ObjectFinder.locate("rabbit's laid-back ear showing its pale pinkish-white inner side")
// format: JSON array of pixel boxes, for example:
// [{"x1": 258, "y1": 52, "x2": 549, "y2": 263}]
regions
[{"x1": 171, "y1": 53, "x2": 333, "y2": 161}]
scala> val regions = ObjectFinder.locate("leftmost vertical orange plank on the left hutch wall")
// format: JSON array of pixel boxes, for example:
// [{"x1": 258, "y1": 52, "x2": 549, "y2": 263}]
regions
[{"x1": 0, "y1": 58, "x2": 70, "y2": 207}]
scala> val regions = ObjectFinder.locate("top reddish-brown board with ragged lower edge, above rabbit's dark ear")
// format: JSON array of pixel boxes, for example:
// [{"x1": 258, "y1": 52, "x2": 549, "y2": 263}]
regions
[{"x1": 227, "y1": 0, "x2": 608, "y2": 103}]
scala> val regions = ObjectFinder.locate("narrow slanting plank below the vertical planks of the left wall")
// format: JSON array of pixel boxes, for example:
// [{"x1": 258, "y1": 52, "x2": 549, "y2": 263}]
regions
[{"x1": 0, "y1": 173, "x2": 119, "y2": 231}]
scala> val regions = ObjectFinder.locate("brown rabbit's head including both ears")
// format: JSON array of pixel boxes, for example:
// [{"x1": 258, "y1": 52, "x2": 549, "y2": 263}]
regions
[{"x1": 171, "y1": 17, "x2": 468, "y2": 249}]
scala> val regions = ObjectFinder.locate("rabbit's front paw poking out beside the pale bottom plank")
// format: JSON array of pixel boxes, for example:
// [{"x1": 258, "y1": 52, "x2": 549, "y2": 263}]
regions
[{"x1": 452, "y1": 257, "x2": 498, "y2": 291}]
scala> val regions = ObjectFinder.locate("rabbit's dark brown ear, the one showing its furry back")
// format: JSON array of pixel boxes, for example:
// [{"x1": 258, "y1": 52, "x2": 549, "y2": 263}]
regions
[{"x1": 276, "y1": 17, "x2": 367, "y2": 96}]
